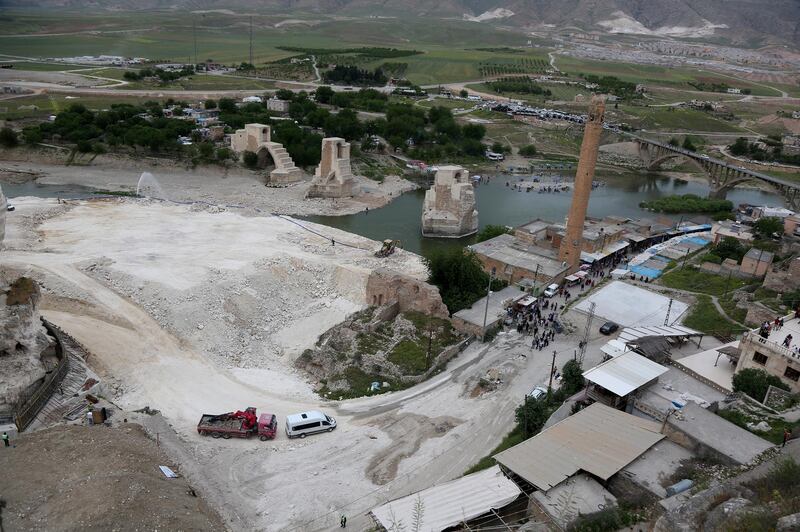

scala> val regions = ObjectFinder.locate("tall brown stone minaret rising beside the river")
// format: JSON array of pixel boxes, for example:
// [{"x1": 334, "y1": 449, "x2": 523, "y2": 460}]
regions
[{"x1": 558, "y1": 96, "x2": 606, "y2": 271}]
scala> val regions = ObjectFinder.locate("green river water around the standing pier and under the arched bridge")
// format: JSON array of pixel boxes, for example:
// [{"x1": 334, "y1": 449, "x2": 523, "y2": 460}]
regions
[{"x1": 304, "y1": 174, "x2": 783, "y2": 256}]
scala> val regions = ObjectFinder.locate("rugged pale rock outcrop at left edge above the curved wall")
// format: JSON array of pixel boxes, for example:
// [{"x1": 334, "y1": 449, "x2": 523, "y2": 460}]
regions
[{"x1": 0, "y1": 277, "x2": 53, "y2": 411}]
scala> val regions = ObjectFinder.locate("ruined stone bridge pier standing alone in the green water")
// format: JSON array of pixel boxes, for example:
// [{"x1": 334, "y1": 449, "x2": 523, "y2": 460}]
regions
[{"x1": 422, "y1": 166, "x2": 478, "y2": 238}]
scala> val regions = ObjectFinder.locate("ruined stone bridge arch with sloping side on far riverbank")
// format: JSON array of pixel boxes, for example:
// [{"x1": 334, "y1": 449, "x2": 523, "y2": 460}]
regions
[{"x1": 231, "y1": 124, "x2": 303, "y2": 184}]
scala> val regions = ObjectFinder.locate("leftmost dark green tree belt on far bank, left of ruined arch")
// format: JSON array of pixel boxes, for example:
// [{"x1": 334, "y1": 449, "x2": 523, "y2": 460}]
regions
[{"x1": 23, "y1": 101, "x2": 194, "y2": 152}]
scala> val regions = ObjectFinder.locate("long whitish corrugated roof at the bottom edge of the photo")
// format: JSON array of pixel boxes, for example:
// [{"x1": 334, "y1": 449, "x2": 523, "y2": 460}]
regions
[{"x1": 370, "y1": 466, "x2": 521, "y2": 532}]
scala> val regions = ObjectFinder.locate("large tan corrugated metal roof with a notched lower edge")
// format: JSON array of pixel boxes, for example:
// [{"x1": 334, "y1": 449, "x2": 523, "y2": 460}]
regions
[{"x1": 494, "y1": 403, "x2": 664, "y2": 490}]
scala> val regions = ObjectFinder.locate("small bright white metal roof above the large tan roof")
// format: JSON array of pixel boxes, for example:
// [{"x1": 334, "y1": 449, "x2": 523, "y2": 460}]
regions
[{"x1": 583, "y1": 351, "x2": 667, "y2": 397}]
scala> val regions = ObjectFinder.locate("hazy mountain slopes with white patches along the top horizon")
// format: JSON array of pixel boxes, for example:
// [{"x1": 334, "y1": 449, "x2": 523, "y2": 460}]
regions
[{"x1": 6, "y1": 0, "x2": 800, "y2": 45}]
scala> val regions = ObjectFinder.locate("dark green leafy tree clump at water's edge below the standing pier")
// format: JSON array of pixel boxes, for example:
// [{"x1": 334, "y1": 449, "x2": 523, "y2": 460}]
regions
[{"x1": 427, "y1": 248, "x2": 506, "y2": 313}]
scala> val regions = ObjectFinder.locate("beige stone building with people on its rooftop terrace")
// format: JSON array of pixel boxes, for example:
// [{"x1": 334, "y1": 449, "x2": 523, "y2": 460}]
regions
[{"x1": 736, "y1": 316, "x2": 800, "y2": 399}]
